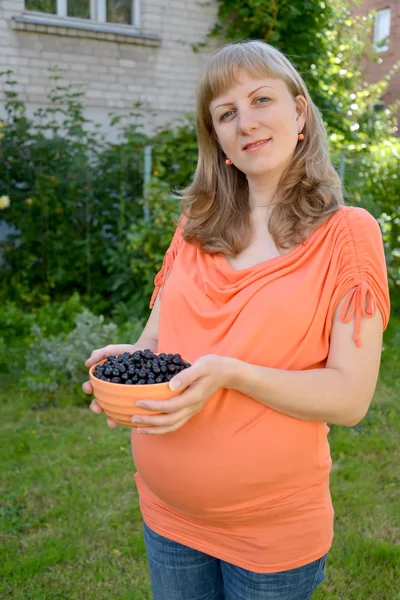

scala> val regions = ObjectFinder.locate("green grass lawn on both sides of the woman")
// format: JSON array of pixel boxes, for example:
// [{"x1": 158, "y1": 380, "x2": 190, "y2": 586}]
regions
[{"x1": 0, "y1": 348, "x2": 400, "y2": 600}]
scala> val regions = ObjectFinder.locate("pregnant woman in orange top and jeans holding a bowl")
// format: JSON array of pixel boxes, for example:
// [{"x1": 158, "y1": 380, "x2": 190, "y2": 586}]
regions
[{"x1": 83, "y1": 41, "x2": 389, "y2": 600}]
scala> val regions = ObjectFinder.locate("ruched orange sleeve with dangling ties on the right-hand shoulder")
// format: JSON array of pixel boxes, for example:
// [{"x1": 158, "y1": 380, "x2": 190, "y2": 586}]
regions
[{"x1": 335, "y1": 207, "x2": 390, "y2": 348}]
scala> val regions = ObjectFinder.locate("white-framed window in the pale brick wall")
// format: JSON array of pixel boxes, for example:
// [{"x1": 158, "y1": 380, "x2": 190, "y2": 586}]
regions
[{"x1": 25, "y1": 0, "x2": 139, "y2": 27}]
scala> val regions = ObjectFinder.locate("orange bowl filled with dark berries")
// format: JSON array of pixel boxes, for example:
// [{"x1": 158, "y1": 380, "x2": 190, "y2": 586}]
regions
[{"x1": 89, "y1": 349, "x2": 191, "y2": 427}]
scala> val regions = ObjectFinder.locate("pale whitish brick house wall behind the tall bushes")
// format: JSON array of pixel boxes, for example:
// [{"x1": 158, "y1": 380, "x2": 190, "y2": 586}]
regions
[{"x1": 0, "y1": 0, "x2": 220, "y2": 136}]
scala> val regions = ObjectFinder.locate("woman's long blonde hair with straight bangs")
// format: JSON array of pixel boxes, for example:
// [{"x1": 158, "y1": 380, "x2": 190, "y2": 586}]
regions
[{"x1": 179, "y1": 40, "x2": 343, "y2": 256}]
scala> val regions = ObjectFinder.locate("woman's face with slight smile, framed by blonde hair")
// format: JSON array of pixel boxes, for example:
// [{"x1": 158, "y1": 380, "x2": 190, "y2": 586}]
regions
[{"x1": 210, "y1": 70, "x2": 307, "y2": 178}]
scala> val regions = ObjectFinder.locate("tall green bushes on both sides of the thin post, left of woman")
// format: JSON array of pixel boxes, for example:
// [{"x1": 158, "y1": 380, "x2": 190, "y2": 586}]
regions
[{"x1": 0, "y1": 72, "x2": 197, "y2": 317}]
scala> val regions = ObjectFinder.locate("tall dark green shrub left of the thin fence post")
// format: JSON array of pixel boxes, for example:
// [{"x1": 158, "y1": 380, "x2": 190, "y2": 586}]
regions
[{"x1": 0, "y1": 74, "x2": 146, "y2": 308}]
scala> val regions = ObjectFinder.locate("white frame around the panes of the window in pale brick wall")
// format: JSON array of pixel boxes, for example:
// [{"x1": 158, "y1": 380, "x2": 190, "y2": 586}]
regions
[{"x1": 24, "y1": 0, "x2": 140, "y2": 29}]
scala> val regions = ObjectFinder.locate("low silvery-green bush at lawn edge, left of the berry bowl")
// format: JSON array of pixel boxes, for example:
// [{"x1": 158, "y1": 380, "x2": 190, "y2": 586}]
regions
[{"x1": 0, "y1": 293, "x2": 144, "y2": 403}]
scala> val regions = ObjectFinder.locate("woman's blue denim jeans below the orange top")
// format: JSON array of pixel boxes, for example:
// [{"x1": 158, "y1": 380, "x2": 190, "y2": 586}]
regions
[{"x1": 144, "y1": 523, "x2": 327, "y2": 600}]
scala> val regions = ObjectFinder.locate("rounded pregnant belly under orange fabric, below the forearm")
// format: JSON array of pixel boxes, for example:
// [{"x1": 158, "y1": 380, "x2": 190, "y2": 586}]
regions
[{"x1": 132, "y1": 399, "x2": 329, "y2": 523}]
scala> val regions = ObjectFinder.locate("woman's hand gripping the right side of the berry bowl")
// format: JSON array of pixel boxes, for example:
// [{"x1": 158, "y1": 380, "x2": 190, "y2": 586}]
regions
[{"x1": 132, "y1": 354, "x2": 228, "y2": 434}]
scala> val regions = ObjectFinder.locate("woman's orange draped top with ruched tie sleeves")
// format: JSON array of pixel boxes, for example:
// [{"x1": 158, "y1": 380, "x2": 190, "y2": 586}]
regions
[{"x1": 132, "y1": 207, "x2": 389, "y2": 573}]
